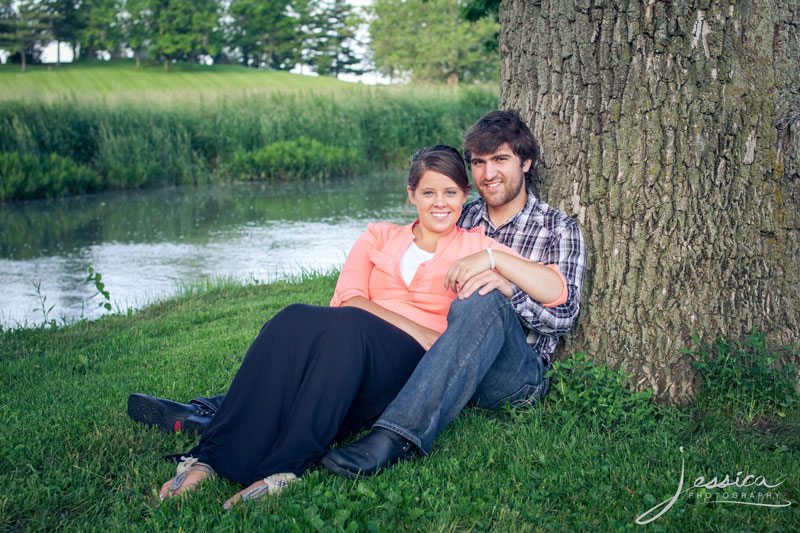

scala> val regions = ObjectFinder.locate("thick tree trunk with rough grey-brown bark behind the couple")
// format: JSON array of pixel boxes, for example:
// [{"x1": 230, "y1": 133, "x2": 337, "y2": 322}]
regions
[{"x1": 500, "y1": 0, "x2": 800, "y2": 402}]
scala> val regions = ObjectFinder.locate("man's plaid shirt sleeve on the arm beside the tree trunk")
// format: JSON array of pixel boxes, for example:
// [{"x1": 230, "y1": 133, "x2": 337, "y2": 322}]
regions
[{"x1": 511, "y1": 223, "x2": 586, "y2": 337}]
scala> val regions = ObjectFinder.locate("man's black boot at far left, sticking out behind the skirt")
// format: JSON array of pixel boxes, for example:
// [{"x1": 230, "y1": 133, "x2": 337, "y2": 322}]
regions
[{"x1": 128, "y1": 394, "x2": 213, "y2": 433}]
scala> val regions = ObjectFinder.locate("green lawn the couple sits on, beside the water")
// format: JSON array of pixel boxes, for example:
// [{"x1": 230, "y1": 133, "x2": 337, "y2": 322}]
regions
[{"x1": 0, "y1": 275, "x2": 800, "y2": 531}]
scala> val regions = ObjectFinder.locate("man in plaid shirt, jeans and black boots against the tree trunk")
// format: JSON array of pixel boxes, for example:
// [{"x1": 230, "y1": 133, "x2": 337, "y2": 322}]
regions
[{"x1": 128, "y1": 111, "x2": 586, "y2": 478}]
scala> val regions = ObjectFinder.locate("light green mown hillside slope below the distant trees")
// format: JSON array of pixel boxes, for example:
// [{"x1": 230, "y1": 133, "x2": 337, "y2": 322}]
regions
[{"x1": 0, "y1": 61, "x2": 358, "y2": 99}]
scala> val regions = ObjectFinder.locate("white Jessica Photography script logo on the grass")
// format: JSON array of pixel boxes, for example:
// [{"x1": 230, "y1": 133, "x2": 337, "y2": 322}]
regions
[{"x1": 636, "y1": 446, "x2": 792, "y2": 525}]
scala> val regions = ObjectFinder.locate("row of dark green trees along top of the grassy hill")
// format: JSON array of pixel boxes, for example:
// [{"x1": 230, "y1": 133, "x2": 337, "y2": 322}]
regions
[{"x1": 0, "y1": 0, "x2": 362, "y2": 76}]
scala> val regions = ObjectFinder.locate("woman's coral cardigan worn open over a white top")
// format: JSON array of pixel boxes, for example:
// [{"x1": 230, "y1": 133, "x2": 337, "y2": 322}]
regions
[{"x1": 331, "y1": 221, "x2": 566, "y2": 333}]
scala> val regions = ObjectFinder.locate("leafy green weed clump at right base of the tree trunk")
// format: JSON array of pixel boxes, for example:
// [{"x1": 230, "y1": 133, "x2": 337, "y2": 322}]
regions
[{"x1": 683, "y1": 330, "x2": 800, "y2": 424}]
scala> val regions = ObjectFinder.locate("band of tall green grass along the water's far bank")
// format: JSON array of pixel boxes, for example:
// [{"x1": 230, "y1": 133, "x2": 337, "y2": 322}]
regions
[{"x1": 0, "y1": 87, "x2": 497, "y2": 201}]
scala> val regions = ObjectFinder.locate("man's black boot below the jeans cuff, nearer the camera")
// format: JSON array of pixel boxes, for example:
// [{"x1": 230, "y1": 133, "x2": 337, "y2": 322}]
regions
[{"x1": 320, "y1": 428, "x2": 418, "y2": 479}]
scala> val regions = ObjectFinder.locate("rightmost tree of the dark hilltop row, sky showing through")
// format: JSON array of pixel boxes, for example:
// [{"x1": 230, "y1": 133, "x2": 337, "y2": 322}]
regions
[{"x1": 305, "y1": 0, "x2": 364, "y2": 77}]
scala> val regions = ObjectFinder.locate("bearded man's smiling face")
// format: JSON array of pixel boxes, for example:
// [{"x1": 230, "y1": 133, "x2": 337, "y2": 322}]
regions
[{"x1": 470, "y1": 143, "x2": 531, "y2": 207}]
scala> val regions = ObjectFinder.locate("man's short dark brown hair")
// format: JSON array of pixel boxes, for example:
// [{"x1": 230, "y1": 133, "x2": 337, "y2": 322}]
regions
[{"x1": 464, "y1": 109, "x2": 540, "y2": 189}]
